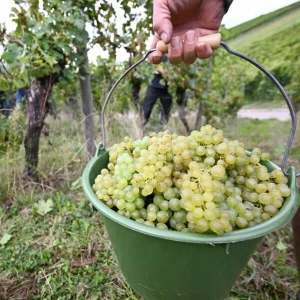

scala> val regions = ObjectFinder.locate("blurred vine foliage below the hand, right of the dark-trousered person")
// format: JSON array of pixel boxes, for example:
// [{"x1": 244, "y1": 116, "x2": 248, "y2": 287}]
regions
[{"x1": 162, "y1": 50, "x2": 244, "y2": 126}]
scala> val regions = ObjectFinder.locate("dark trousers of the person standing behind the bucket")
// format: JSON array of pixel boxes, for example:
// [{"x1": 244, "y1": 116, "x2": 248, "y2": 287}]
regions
[{"x1": 144, "y1": 85, "x2": 172, "y2": 124}]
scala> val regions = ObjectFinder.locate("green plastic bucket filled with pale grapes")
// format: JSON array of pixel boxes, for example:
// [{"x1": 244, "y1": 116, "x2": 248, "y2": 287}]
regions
[{"x1": 82, "y1": 150, "x2": 299, "y2": 300}]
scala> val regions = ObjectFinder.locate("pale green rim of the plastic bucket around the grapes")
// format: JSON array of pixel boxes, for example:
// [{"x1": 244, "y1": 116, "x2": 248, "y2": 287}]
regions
[{"x1": 82, "y1": 155, "x2": 300, "y2": 244}]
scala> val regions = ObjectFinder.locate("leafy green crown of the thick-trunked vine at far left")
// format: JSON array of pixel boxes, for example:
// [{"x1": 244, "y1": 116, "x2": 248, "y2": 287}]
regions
[{"x1": 1, "y1": 0, "x2": 88, "y2": 89}]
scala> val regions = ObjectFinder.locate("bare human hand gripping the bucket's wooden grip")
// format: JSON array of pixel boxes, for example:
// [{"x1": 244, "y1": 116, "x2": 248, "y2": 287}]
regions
[{"x1": 150, "y1": 0, "x2": 225, "y2": 64}]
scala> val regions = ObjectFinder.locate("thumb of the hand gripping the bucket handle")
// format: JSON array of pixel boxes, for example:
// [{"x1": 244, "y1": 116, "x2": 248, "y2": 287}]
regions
[{"x1": 153, "y1": 0, "x2": 173, "y2": 44}]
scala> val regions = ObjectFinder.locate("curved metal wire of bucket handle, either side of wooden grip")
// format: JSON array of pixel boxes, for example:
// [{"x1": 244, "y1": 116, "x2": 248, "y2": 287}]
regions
[{"x1": 98, "y1": 41, "x2": 300, "y2": 177}]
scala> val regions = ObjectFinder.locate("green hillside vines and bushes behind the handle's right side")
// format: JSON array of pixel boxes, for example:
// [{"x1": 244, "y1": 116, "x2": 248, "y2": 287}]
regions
[{"x1": 225, "y1": 20, "x2": 300, "y2": 109}]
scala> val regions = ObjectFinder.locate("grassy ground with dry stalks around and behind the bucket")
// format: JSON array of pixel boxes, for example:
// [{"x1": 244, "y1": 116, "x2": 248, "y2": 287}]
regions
[{"x1": 0, "y1": 109, "x2": 300, "y2": 300}]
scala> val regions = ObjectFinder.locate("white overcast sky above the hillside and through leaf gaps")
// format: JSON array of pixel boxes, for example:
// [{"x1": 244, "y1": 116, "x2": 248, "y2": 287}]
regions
[{"x1": 0, "y1": 0, "x2": 299, "y2": 61}]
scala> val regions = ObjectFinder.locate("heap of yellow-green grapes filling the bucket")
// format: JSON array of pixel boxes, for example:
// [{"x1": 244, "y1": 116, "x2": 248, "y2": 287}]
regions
[{"x1": 93, "y1": 125, "x2": 290, "y2": 235}]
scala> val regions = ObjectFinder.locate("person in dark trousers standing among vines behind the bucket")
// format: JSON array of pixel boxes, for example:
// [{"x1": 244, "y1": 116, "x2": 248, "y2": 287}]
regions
[{"x1": 142, "y1": 55, "x2": 172, "y2": 128}]
